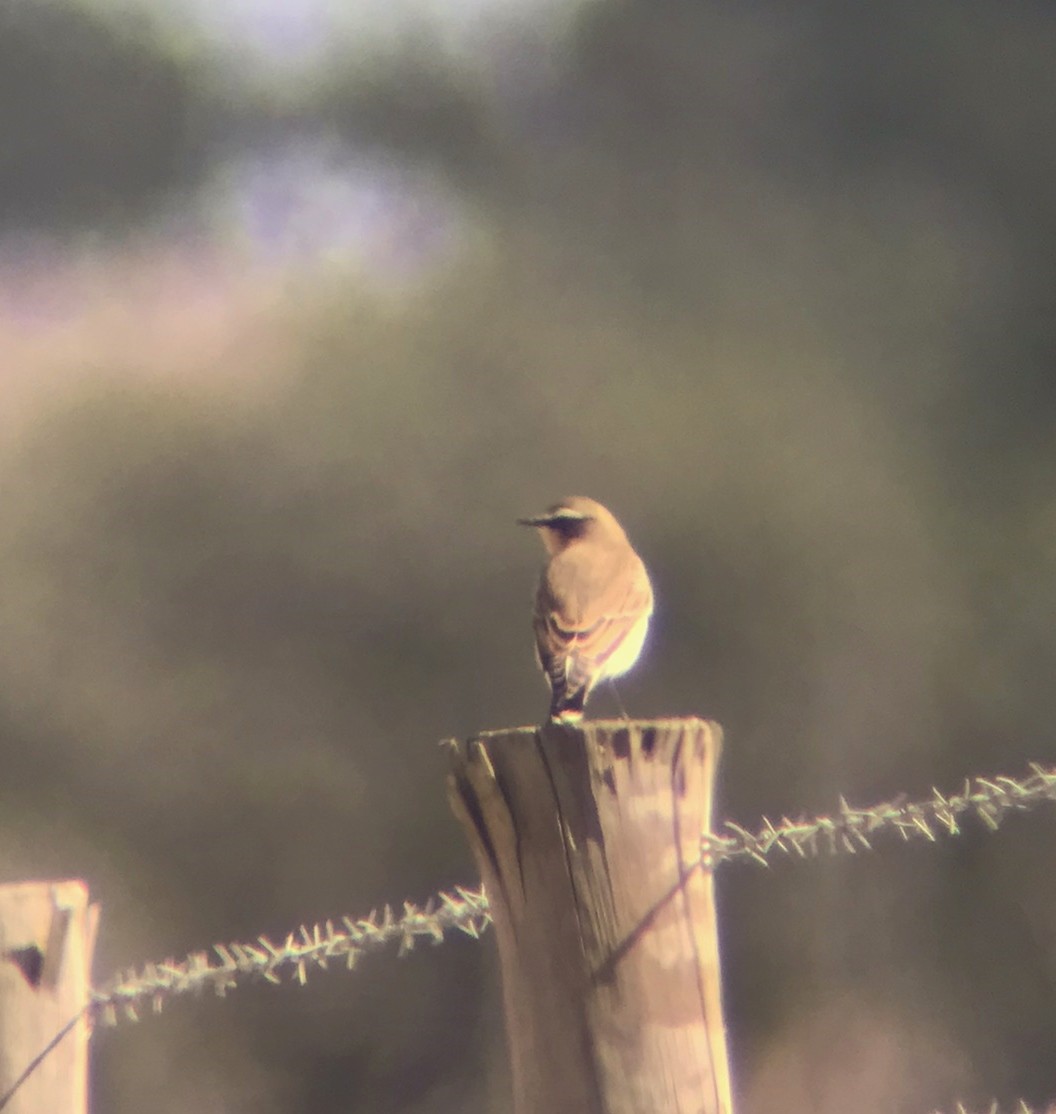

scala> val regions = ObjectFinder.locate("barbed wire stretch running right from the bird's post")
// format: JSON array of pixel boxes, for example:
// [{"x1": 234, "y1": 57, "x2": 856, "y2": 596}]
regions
[{"x1": 701, "y1": 763, "x2": 1056, "y2": 869}]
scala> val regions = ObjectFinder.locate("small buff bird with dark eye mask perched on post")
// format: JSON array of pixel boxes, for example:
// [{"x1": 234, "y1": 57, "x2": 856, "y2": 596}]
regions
[{"x1": 517, "y1": 495, "x2": 653, "y2": 722}]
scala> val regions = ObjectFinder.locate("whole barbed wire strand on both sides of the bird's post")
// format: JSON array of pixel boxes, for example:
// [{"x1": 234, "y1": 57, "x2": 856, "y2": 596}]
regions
[{"x1": 91, "y1": 764, "x2": 1056, "y2": 1024}]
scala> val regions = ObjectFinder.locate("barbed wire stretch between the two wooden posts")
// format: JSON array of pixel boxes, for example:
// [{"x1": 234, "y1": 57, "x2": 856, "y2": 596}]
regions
[{"x1": 91, "y1": 887, "x2": 491, "y2": 1025}]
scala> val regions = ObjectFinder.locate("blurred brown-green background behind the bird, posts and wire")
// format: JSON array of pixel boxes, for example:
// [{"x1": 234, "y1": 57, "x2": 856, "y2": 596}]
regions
[{"x1": 0, "y1": 0, "x2": 1056, "y2": 1114}]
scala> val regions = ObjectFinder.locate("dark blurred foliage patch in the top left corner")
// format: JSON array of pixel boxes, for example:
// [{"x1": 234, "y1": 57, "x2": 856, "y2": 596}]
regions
[{"x1": 0, "y1": 0, "x2": 216, "y2": 232}]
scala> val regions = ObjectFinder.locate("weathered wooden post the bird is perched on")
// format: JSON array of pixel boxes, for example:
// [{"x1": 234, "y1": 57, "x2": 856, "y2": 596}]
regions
[{"x1": 441, "y1": 719, "x2": 732, "y2": 1114}]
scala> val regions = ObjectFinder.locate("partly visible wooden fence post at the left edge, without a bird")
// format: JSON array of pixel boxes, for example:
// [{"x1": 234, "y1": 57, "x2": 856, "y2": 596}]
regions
[{"x1": 0, "y1": 881, "x2": 99, "y2": 1114}]
